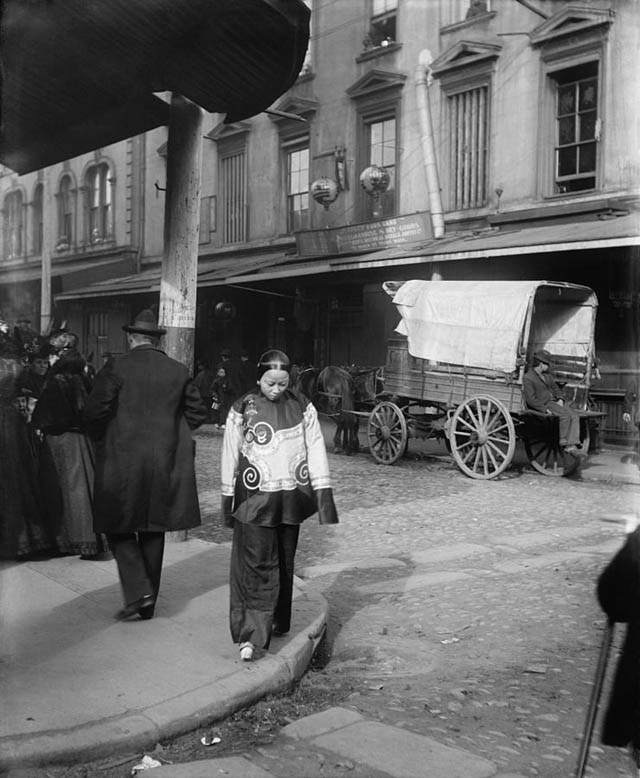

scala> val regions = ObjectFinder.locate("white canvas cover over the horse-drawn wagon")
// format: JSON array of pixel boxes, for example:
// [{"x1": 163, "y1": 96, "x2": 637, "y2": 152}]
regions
[{"x1": 383, "y1": 280, "x2": 597, "y2": 372}]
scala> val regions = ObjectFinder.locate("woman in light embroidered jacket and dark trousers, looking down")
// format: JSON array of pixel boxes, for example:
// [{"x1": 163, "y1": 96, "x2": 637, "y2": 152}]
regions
[{"x1": 222, "y1": 349, "x2": 338, "y2": 660}]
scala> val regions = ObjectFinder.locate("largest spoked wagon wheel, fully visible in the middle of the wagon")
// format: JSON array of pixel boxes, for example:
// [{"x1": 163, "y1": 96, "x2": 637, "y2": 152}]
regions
[{"x1": 449, "y1": 395, "x2": 516, "y2": 479}]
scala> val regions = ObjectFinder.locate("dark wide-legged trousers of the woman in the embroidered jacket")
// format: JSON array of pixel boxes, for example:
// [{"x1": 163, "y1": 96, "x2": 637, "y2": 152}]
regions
[{"x1": 229, "y1": 521, "x2": 300, "y2": 649}]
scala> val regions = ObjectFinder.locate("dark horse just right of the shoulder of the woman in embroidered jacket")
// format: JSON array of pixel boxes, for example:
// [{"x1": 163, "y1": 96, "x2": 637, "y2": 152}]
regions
[{"x1": 314, "y1": 365, "x2": 360, "y2": 455}]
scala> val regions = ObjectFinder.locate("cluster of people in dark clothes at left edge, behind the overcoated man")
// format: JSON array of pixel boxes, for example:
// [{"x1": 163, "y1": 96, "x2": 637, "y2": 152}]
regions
[{"x1": 0, "y1": 320, "x2": 107, "y2": 559}]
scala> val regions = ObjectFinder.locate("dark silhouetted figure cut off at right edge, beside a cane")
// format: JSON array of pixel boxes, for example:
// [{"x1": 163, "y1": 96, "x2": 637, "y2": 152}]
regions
[{"x1": 598, "y1": 529, "x2": 640, "y2": 749}]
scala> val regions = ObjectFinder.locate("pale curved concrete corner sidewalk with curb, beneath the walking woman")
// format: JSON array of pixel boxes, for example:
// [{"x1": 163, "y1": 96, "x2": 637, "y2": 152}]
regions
[{"x1": 0, "y1": 539, "x2": 327, "y2": 772}]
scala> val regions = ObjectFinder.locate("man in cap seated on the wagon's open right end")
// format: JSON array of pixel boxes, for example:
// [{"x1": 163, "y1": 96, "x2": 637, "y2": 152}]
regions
[{"x1": 522, "y1": 349, "x2": 581, "y2": 454}]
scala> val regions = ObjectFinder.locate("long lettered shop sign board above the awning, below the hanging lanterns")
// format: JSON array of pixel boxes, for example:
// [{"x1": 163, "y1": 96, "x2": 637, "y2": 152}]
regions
[{"x1": 295, "y1": 211, "x2": 433, "y2": 257}]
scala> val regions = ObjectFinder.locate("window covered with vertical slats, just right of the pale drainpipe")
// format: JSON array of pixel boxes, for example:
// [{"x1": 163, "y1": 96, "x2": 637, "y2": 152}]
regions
[{"x1": 447, "y1": 86, "x2": 489, "y2": 210}]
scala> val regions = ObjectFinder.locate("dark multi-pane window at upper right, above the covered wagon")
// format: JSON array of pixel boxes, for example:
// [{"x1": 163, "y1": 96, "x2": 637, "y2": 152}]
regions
[{"x1": 550, "y1": 62, "x2": 600, "y2": 194}]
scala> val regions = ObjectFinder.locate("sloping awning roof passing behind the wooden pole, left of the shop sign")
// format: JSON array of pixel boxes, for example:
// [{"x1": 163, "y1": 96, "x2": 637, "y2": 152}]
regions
[{"x1": 55, "y1": 253, "x2": 291, "y2": 300}]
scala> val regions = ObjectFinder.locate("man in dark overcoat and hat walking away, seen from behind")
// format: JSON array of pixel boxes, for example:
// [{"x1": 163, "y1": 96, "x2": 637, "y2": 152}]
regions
[{"x1": 84, "y1": 310, "x2": 206, "y2": 619}]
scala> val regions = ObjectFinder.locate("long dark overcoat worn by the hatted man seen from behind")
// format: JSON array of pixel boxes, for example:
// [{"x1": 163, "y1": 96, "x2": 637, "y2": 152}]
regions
[{"x1": 84, "y1": 344, "x2": 206, "y2": 533}]
